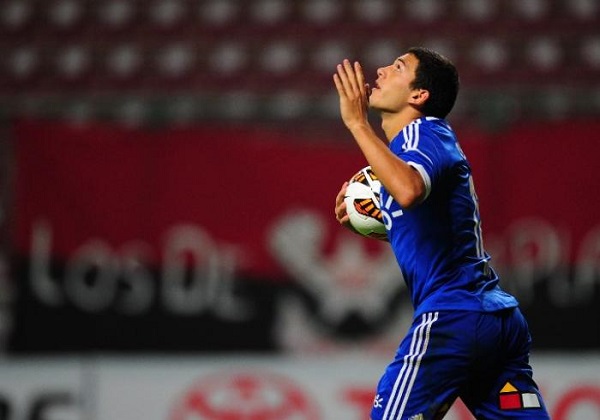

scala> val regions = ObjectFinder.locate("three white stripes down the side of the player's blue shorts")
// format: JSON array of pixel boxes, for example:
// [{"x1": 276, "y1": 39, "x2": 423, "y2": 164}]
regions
[{"x1": 382, "y1": 312, "x2": 438, "y2": 420}]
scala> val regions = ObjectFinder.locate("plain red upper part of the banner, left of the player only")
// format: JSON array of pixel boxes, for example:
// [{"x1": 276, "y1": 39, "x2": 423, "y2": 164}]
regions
[{"x1": 15, "y1": 122, "x2": 364, "y2": 277}]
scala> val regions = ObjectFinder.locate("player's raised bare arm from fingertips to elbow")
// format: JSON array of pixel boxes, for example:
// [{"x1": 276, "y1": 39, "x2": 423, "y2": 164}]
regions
[{"x1": 333, "y1": 60, "x2": 426, "y2": 209}]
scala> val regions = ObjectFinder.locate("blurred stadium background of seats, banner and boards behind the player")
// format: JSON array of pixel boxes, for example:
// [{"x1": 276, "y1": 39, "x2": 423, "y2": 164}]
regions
[{"x1": 0, "y1": 0, "x2": 600, "y2": 420}]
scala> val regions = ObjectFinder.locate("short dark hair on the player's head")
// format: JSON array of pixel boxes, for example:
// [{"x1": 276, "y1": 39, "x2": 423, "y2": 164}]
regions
[{"x1": 408, "y1": 47, "x2": 460, "y2": 118}]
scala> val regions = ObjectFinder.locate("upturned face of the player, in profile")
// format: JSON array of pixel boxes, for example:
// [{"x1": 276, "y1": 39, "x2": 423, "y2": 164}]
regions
[{"x1": 369, "y1": 54, "x2": 419, "y2": 112}]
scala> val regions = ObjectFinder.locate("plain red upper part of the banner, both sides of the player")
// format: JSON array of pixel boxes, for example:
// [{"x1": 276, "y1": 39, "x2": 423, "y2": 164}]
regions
[{"x1": 14, "y1": 122, "x2": 600, "y2": 277}]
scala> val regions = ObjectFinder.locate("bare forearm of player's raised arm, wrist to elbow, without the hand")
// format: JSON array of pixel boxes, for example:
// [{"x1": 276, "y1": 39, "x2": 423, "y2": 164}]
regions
[{"x1": 350, "y1": 125, "x2": 425, "y2": 209}]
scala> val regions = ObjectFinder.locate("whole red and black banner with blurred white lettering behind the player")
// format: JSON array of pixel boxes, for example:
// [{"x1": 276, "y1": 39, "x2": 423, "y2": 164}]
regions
[{"x1": 12, "y1": 121, "x2": 600, "y2": 350}]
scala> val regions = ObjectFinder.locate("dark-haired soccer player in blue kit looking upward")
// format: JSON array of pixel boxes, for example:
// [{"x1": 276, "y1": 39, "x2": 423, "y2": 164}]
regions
[{"x1": 333, "y1": 48, "x2": 549, "y2": 420}]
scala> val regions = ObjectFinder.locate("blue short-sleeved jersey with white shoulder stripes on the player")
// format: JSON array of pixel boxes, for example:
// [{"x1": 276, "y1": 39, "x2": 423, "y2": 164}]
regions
[{"x1": 380, "y1": 117, "x2": 517, "y2": 316}]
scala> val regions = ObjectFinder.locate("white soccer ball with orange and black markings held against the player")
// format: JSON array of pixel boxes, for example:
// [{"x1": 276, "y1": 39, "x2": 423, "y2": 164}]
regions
[{"x1": 344, "y1": 166, "x2": 387, "y2": 238}]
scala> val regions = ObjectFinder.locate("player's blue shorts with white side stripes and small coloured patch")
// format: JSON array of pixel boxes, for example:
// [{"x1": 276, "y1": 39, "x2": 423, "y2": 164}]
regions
[{"x1": 371, "y1": 308, "x2": 550, "y2": 420}]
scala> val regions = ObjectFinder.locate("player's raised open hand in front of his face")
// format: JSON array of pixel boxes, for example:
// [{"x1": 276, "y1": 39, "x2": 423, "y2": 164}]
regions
[{"x1": 333, "y1": 59, "x2": 370, "y2": 130}]
